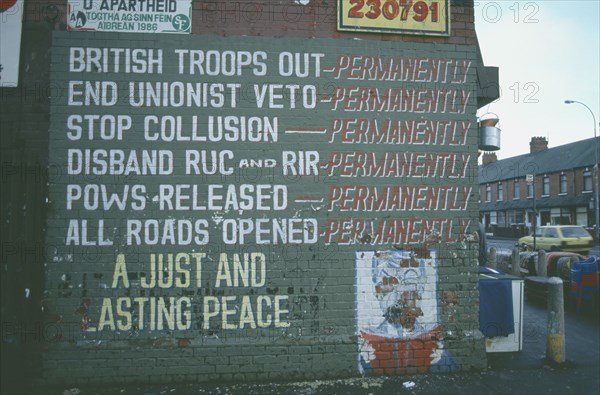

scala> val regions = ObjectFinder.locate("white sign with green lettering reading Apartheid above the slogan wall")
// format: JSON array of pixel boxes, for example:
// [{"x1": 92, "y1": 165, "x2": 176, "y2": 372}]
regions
[{"x1": 67, "y1": 0, "x2": 192, "y2": 34}]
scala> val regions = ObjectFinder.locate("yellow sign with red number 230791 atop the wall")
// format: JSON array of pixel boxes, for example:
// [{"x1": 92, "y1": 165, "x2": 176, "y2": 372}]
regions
[{"x1": 338, "y1": 0, "x2": 450, "y2": 36}]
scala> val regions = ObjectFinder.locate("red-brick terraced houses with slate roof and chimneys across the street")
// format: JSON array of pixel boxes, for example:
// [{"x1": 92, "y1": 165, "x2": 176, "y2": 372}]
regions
[{"x1": 479, "y1": 137, "x2": 598, "y2": 237}]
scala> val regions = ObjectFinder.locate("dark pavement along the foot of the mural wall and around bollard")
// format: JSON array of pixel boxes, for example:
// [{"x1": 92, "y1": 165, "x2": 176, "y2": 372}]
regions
[{"x1": 7, "y1": 300, "x2": 600, "y2": 395}]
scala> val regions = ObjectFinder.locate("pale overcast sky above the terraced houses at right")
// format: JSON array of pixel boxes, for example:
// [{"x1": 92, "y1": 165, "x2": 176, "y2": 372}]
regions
[{"x1": 475, "y1": 0, "x2": 600, "y2": 159}]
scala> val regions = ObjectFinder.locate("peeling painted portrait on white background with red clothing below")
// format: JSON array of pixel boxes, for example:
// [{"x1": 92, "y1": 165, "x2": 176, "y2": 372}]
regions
[{"x1": 356, "y1": 250, "x2": 456, "y2": 375}]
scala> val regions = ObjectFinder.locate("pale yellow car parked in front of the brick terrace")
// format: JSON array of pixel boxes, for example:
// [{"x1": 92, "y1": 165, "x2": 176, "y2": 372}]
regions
[{"x1": 517, "y1": 225, "x2": 594, "y2": 255}]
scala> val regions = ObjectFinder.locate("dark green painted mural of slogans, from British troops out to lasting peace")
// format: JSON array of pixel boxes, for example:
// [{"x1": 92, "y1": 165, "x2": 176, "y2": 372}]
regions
[{"x1": 45, "y1": 28, "x2": 477, "y2": 375}]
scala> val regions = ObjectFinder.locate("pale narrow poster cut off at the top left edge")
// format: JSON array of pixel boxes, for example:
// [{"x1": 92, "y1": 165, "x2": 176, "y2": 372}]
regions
[{"x1": 0, "y1": 0, "x2": 24, "y2": 88}]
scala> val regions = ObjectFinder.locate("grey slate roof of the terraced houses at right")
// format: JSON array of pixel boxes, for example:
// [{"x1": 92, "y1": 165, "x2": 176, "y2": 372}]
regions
[{"x1": 479, "y1": 137, "x2": 600, "y2": 183}]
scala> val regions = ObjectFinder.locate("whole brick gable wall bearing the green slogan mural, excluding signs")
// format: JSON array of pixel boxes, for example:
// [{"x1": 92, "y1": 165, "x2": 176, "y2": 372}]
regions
[{"x1": 2, "y1": 2, "x2": 485, "y2": 383}]
